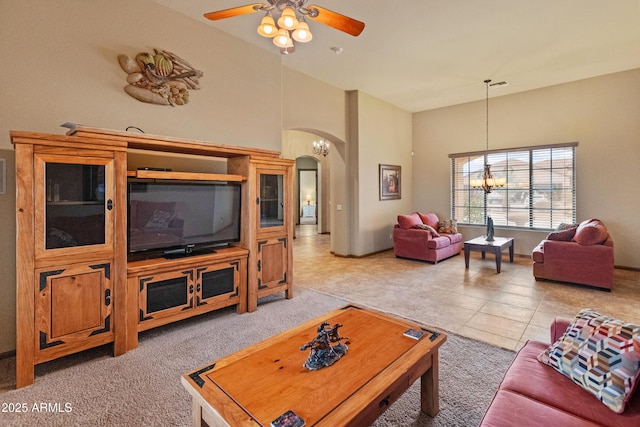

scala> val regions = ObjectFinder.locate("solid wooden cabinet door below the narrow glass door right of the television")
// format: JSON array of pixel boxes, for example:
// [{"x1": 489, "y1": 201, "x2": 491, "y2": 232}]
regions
[{"x1": 258, "y1": 237, "x2": 288, "y2": 293}]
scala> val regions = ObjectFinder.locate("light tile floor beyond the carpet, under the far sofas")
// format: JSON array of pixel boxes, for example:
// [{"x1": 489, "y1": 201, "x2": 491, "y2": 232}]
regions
[{"x1": 293, "y1": 225, "x2": 640, "y2": 350}]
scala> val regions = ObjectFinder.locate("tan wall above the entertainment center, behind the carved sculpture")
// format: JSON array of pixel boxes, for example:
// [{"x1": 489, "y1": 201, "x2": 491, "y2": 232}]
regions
[{"x1": 0, "y1": 0, "x2": 282, "y2": 150}]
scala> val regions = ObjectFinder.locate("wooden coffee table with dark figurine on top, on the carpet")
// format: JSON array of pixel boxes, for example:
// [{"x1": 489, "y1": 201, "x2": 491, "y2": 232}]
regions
[{"x1": 182, "y1": 305, "x2": 447, "y2": 427}]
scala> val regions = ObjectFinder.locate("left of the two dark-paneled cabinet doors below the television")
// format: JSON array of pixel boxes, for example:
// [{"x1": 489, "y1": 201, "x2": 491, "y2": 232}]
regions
[{"x1": 138, "y1": 268, "x2": 195, "y2": 326}]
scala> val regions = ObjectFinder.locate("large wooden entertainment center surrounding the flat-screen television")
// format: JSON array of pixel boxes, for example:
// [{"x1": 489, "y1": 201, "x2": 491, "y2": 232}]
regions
[{"x1": 11, "y1": 126, "x2": 294, "y2": 388}]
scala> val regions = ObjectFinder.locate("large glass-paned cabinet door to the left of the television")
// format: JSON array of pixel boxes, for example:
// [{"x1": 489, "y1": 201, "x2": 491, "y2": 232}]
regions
[{"x1": 36, "y1": 155, "x2": 113, "y2": 255}]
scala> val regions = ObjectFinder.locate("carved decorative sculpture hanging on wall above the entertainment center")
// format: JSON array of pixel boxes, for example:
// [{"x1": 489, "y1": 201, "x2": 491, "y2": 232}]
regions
[{"x1": 118, "y1": 49, "x2": 202, "y2": 107}]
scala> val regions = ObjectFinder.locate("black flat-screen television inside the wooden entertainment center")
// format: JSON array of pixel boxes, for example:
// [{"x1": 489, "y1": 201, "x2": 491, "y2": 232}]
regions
[{"x1": 127, "y1": 181, "x2": 241, "y2": 260}]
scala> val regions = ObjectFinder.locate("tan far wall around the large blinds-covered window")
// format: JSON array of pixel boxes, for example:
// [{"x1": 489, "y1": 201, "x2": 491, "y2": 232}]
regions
[{"x1": 413, "y1": 69, "x2": 640, "y2": 268}]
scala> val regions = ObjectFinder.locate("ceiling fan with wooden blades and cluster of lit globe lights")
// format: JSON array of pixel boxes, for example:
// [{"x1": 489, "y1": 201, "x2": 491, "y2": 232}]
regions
[{"x1": 204, "y1": 0, "x2": 364, "y2": 54}]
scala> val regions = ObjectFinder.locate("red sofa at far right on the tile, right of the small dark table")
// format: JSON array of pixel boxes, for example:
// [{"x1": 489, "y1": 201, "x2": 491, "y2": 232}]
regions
[{"x1": 531, "y1": 219, "x2": 614, "y2": 290}]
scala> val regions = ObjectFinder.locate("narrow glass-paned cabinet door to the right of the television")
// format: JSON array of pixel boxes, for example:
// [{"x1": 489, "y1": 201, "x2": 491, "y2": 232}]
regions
[{"x1": 258, "y1": 171, "x2": 285, "y2": 229}]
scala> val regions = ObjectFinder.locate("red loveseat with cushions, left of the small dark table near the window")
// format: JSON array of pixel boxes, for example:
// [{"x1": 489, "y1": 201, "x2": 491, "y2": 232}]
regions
[{"x1": 393, "y1": 212, "x2": 463, "y2": 264}]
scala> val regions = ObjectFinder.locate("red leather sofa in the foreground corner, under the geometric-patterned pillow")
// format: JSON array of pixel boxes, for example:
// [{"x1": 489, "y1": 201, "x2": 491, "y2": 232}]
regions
[{"x1": 480, "y1": 319, "x2": 640, "y2": 427}]
